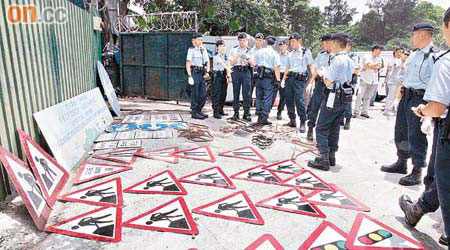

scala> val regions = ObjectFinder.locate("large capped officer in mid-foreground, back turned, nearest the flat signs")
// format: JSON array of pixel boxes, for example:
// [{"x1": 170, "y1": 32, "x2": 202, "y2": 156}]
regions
[{"x1": 308, "y1": 33, "x2": 354, "y2": 171}]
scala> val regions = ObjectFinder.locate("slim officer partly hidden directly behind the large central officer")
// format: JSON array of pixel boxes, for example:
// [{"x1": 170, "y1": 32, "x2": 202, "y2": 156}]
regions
[{"x1": 306, "y1": 34, "x2": 333, "y2": 141}]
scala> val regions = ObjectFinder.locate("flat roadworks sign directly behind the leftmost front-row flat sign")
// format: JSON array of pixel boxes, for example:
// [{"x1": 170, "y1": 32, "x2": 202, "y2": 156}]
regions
[{"x1": 59, "y1": 178, "x2": 123, "y2": 206}]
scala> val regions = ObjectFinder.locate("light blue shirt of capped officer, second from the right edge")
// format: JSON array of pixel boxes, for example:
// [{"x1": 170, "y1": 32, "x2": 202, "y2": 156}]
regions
[{"x1": 403, "y1": 43, "x2": 434, "y2": 89}]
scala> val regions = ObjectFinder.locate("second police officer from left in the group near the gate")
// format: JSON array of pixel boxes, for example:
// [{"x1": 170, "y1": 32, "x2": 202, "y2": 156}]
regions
[{"x1": 212, "y1": 40, "x2": 231, "y2": 119}]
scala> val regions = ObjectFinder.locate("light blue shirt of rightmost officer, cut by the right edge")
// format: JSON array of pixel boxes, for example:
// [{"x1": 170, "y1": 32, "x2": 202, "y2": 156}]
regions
[{"x1": 423, "y1": 50, "x2": 450, "y2": 118}]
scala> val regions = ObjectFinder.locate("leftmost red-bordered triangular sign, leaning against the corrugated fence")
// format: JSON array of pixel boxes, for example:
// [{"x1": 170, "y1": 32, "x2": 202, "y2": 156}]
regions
[{"x1": 0, "y1": 146, "x2": 51, "y2": 230}]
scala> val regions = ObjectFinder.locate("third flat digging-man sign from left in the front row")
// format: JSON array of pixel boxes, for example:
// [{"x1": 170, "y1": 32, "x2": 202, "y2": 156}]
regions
[{"x1": 192, "y1": 191, "x2": 264, "y2": 225}]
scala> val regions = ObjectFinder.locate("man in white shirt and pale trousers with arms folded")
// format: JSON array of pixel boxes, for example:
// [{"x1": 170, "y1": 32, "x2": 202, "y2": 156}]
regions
[{"x1": 353, "y1": 45, "x2": 384, "y2": 118}]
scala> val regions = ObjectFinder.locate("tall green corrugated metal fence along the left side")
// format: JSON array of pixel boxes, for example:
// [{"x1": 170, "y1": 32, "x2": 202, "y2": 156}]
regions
[{"x1": 0, "y1": 0, "x2": 98, "y2": 200}]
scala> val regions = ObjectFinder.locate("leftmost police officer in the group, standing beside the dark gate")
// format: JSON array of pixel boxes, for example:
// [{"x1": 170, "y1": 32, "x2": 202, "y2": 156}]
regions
[{"x1": 186, "y1": 32, "x2": 210, "y2": 120}]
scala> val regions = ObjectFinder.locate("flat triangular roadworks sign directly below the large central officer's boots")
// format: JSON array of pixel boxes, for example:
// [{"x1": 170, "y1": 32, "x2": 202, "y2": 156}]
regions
[{"x1": 283, "y1": 170, "x2": 332, "y2": 190}]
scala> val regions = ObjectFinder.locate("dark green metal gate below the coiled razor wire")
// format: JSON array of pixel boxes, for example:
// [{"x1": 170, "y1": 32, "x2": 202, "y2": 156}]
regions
[{"x1": 120, "y1": 32, "x2": 192, "y2": 100}]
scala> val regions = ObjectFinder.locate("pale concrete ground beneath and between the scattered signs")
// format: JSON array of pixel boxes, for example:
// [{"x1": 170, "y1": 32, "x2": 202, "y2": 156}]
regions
[{"x1": 0, "y1": 99, "x2": 444, "y2": 250}]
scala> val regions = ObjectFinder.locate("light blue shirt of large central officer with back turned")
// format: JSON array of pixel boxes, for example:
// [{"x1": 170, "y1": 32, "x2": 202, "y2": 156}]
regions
[{"x1": 324, "y1": 51, "x2": 355, "y2": 89}]
